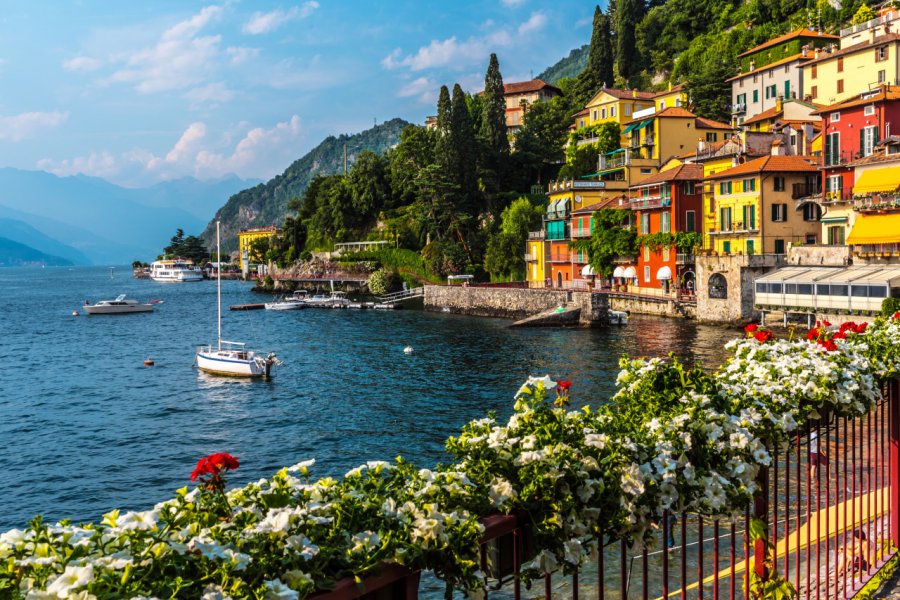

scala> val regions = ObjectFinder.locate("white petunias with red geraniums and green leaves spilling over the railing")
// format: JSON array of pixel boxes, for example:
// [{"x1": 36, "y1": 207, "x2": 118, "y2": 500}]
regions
[{"x1": 0, "y1": 314, "x2": 900, "y2": 599}]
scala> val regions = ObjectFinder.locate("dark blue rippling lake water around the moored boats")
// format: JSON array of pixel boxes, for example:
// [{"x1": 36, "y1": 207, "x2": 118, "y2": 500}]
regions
[{"x1": 0, "y1": 267, "x2": 737, "y2": 531}]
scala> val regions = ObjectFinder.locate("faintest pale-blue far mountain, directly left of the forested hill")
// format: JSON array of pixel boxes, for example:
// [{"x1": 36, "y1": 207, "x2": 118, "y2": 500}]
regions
[{"x1": 135, "y1": 175, "x2": 262, "y2": 223}]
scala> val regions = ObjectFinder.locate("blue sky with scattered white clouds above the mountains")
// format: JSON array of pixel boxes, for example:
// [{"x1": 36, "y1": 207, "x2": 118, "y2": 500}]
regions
[{"x1": 0, "y1": 0, "x2": 605, "y2": 187}]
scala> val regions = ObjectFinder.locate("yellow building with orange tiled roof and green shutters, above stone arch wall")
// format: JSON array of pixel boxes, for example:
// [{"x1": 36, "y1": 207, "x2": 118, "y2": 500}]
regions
[{"x1": 705, "y1": 155, "x2": 822, "y2": 254}]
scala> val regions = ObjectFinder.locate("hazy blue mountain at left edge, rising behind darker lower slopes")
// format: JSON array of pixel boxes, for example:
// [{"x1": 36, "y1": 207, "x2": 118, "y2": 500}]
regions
[{"x1": 0, "y1": 168, "x2": 208, "y2": 264}]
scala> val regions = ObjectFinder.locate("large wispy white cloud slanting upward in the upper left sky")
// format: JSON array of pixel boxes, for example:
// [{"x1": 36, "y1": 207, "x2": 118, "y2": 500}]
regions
[{"x1": 110, "y1": 6, "x2": 223, "y2": 93}]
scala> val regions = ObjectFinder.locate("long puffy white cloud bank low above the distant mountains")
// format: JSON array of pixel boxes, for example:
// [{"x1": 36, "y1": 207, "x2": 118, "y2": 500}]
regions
[{"x1": 37, "y1": 115, "x2": 302, "y2": 185}]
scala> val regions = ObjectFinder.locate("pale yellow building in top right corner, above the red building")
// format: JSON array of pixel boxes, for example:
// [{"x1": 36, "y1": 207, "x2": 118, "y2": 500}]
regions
[{"x1": 803, "y1": 19, "x2": 900, "y2": 104}]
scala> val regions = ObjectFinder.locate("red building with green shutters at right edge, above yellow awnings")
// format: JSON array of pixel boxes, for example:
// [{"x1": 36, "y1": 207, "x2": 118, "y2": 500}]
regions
[{"x1": 814, "y1": 85, "x2": 900, "y2": 204}]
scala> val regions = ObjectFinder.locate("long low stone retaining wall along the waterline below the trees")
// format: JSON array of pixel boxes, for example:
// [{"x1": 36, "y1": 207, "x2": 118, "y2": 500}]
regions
[{"x1": 424, "y1": 285, "x2": 608, "y2": 326}]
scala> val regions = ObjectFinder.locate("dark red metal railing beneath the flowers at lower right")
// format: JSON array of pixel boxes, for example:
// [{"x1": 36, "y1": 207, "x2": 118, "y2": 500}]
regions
[{"x1": 321, "y1": 380, "x2": 900, "y2": 600}]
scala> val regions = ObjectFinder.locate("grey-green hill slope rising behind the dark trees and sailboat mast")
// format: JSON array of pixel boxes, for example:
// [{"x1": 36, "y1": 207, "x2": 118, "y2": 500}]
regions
[{"x1": 201, "y1": 119, "x2": 409, "y2": 251}]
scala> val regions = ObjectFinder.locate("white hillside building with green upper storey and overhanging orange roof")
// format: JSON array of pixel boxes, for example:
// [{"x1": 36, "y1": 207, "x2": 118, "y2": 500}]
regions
[{"x1": 728, "y1": 29, "x2": 839, "y2": 125}]
